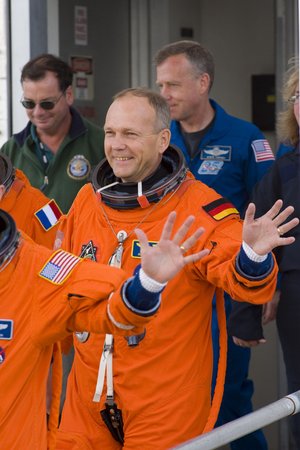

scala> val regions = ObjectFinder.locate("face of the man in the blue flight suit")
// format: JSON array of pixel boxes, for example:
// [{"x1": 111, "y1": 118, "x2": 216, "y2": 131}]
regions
[{"x1": 156, "y1": 54, "x2": 209, "y2": 121}]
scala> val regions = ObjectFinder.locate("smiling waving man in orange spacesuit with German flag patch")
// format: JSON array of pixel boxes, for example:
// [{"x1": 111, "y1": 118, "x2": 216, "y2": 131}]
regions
[{"x1": 57, "y1": 88, "x2": 299, "y2": 450}]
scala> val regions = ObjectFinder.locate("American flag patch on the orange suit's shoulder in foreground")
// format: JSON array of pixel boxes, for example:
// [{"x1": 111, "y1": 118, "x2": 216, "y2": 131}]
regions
[{"x1": 39, "y1": 250, "x2": 83, "y2": 284}]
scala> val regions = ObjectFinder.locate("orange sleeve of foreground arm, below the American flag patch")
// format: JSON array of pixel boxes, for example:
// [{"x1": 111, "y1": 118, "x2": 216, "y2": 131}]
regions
[{"x1": 34, "y1": 260, "x2": 155, "y2": 345}]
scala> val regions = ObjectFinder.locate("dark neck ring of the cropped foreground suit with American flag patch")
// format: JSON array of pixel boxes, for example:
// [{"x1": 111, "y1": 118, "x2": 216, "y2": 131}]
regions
[{"x1": 0, "y1": 209, "x2": 20, "y2": 270}]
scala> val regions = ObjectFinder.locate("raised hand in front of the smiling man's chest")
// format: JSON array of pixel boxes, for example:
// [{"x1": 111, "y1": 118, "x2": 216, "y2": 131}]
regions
[{"x1": 135, "y1": 211, "x2": 209, "y2": 283}]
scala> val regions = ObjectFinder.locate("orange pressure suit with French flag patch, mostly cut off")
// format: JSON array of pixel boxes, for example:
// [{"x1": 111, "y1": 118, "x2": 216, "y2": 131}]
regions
[{"x1": 0, "y1": 169, "x2": 57, "y2": 248}]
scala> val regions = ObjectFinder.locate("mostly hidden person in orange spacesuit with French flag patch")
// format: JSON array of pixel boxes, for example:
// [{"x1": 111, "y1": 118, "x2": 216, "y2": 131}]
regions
[{"x1": 0, "y1": 153, "x2": 62, "y2": 248}]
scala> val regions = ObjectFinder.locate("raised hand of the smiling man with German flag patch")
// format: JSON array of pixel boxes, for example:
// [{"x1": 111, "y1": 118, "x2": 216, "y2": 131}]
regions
[{"x1": 243, "y1": 200, "x2": 299, "y2": 255}]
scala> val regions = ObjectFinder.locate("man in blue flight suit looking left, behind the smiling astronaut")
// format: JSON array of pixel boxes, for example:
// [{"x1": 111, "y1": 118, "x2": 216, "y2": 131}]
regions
[{"x1": 155, "y1": 41, "x2": 274, "y2": 450}]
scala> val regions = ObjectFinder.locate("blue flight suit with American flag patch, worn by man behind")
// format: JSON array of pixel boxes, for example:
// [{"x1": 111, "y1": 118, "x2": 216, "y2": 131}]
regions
[{"x1": 170, "y1": 100, "x2": 274, "y2": 450}]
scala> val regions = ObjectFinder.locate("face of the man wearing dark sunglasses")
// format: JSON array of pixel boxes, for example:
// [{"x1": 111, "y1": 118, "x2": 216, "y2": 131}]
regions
[{"x1": 22, "y1": 72, "x2": 73, "y2": 134}]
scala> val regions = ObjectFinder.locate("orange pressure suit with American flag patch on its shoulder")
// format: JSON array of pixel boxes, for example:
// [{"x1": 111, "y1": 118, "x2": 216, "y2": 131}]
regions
[{"x1": 0, "y1": 230, "x2": 155, "y2": 450}]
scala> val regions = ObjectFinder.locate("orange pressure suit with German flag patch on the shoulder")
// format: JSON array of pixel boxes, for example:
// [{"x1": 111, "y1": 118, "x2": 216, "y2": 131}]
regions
[{"x1": 57, "y1": 174, "x2": 277, "y2": 450}]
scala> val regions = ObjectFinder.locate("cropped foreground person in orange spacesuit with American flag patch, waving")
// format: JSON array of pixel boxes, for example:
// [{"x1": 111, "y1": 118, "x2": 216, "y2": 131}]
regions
[{"x1": 0, "y1": 210, "x2": 204, "y2": 450}]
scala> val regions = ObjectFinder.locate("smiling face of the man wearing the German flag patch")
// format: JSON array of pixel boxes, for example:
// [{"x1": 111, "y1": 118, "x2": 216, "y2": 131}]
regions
[{"x1": 104, "y1": 95, "x2": 170, "y2": 183}]
